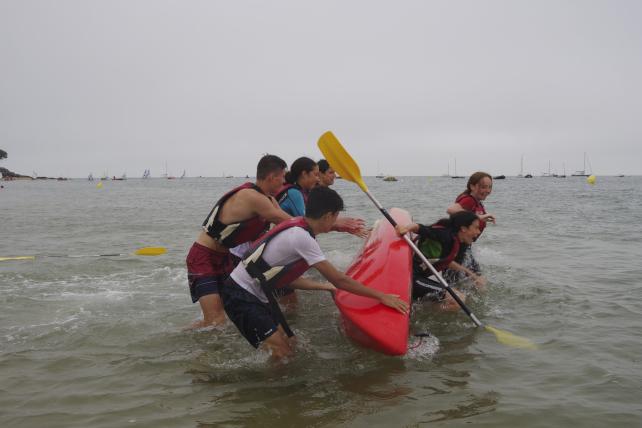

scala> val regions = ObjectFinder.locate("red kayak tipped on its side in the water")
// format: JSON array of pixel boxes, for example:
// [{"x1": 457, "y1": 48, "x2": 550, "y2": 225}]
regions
[{"x1": 335, "y1": 208, "x2": 412, "y2": 355}]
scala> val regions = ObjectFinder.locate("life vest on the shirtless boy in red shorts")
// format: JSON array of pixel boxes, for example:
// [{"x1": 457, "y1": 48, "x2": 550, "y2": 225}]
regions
[{"x1": 203, "y1": 182, "x2": 269, "y2": 248}]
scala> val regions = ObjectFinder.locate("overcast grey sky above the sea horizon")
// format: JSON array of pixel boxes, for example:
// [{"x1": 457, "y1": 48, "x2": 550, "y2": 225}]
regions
[{"x1": 0, "y1": 0, "x2": 642, "y2": 177}]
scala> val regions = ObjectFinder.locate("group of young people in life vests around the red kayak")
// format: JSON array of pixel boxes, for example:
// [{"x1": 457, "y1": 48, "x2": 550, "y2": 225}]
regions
[{"x1": 182, "y1": 155, "x2": 495, "y2": 359}]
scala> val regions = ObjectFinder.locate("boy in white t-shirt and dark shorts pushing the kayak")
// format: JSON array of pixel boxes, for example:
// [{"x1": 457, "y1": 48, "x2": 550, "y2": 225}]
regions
[{"x1": 219, "y1": 187, "x2": 408, "y2": 359}]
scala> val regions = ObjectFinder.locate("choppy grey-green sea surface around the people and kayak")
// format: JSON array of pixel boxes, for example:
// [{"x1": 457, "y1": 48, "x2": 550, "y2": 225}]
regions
[{"x1": 0, "y1": 176, "x2": 642, "y2": 428}]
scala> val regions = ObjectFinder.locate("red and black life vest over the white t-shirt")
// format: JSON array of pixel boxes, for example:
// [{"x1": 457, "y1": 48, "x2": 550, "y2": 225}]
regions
[{"x1": 243, "y1": 217, "x2": 314, "y2": 293}]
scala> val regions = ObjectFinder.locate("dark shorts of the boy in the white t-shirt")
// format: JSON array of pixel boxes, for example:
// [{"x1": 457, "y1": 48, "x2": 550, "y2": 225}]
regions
[{"x1": 218, "y1": 278, "x2": 278, "y2": 348}]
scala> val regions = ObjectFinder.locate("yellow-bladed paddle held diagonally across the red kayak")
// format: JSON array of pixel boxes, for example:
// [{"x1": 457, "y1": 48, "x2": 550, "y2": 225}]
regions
[{"x1": 318, "y1": 131, "x2": 537, "y2": 349}]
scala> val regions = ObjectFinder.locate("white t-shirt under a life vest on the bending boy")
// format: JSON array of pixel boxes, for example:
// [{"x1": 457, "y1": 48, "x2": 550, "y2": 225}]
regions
[{"x1": 230, "y1": 227, "x2": 325, "y2": 303}]
